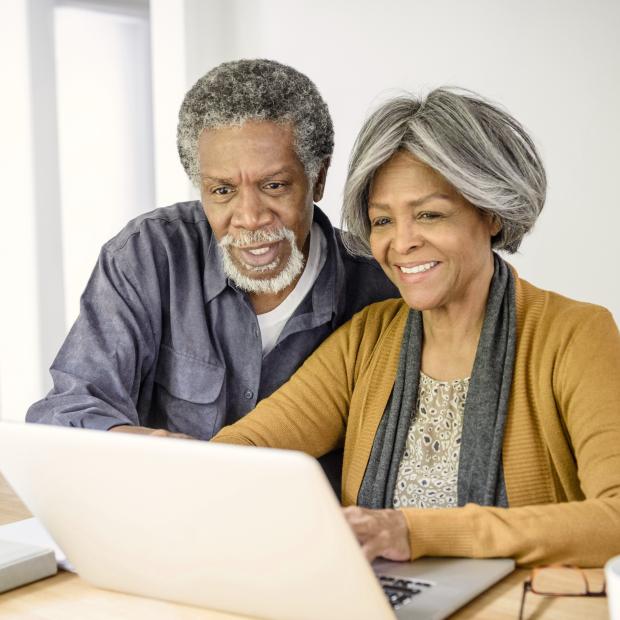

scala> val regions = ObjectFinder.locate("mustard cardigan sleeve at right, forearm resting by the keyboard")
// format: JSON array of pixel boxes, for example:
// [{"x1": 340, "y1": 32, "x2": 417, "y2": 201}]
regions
[{"x1": 404, "y1": 307, "x2": 620, "y2": 567}]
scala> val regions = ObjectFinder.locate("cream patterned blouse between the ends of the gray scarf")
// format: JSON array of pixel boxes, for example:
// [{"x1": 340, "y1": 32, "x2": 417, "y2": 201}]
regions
[{"x1": 392, "y1": 372, "x2": 469, "y2": 508}]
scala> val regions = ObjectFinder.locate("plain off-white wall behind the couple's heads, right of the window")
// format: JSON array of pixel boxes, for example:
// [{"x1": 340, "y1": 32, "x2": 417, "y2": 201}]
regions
[{"x1": 176, "y1": 0, "x2": 620, "y2": 320}]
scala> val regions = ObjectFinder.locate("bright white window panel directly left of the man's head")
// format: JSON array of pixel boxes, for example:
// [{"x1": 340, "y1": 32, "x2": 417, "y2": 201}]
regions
[{"x1": 54, "y1": 3, "x2": 155, "y2": 328}]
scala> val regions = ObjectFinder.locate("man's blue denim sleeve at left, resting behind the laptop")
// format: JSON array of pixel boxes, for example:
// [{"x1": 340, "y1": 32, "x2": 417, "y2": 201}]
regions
[{"x1": 26, "y1": 249, "x2": 160, "y2": 430}]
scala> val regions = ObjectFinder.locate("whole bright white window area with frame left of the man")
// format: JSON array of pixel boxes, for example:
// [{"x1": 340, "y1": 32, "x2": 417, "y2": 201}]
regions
[{"x1": 0, "y1": 0, "x2": 155, "y2": 420}]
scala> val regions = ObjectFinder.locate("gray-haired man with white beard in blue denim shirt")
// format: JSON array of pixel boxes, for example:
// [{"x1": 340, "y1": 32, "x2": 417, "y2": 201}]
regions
[{"x1": 27, "y1": 60, "x2": 397, "y2": 484}]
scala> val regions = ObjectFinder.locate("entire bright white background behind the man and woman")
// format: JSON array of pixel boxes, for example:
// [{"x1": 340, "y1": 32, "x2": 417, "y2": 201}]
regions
[{"x1": 0, "y1": 0, "x2": 620, "y2": 419}]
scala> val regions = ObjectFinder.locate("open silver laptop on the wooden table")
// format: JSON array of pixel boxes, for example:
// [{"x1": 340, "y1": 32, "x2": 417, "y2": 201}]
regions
[{"x1": 0, "y1": 423, "x2": 514, "y2": 620}]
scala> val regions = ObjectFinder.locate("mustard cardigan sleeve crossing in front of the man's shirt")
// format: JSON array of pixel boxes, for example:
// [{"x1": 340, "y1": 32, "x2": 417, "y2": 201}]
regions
[{"x1": 212, "y1": 310, "x2": 368, "y2": 457}]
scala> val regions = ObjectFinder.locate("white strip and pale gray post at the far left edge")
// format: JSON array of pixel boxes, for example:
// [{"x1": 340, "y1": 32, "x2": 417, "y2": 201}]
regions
[{"x1": 0, "y1": 0, "x2": 65, "y2": 419}]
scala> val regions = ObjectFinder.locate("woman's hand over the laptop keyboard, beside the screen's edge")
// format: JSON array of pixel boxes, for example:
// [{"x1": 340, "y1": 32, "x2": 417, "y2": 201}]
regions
[{"x1": 344, "y1": 506, "x2": 411, "y2": 562}]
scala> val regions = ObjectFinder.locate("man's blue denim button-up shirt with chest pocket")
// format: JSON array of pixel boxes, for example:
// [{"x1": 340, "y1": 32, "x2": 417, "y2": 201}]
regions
[{"x1": 26, "y1": 202, "x2": 398, "y2": 439}]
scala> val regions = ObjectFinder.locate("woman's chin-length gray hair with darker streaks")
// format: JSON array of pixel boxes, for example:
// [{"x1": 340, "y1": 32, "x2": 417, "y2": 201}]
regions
[{"x1": 342, "y1": 88, "x2": 547, "y2": 256}]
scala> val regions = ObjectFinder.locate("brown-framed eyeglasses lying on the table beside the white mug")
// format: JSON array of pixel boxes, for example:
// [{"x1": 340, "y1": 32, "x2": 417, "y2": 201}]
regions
[{"x1": 519, "y1": 565, "x2": 605, "y2": 620}]
